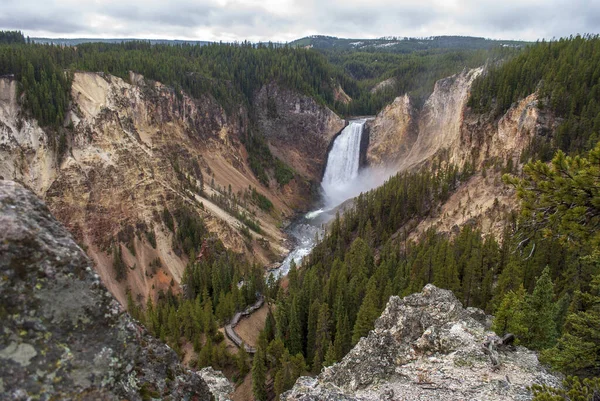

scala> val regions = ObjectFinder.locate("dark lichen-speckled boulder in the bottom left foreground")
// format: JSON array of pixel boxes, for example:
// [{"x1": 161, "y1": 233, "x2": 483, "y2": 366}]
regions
[{"x1": 0, "y1": 180, "x2": 211, "y2": 400}]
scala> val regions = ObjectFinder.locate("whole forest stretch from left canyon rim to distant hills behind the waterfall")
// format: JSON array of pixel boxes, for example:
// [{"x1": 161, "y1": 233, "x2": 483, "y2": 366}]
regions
[{"x1": 0, "y1": 32, "x2": 520, "y2": 126}]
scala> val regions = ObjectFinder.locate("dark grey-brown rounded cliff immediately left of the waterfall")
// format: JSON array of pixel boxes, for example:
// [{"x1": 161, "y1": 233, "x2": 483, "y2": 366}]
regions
[{"x1": 254, "y1": 83, "x2": 345, "y2": 183}]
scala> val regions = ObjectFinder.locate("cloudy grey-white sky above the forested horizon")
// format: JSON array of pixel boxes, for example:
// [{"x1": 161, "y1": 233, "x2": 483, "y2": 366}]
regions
[{"x1": 0, "y1": 0, "x2": 600, "y2": 42}]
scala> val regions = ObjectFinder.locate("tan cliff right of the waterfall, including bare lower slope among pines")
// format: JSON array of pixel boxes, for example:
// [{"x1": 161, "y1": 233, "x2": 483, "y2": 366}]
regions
[{"x1": 367, "y1": 68, "x2": 560, "y2": 239}]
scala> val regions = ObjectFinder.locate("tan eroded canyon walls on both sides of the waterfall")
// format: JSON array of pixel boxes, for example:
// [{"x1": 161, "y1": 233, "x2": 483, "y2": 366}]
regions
[{"x1": 0, "y1": 68, "x2": 558, "y2": 302}]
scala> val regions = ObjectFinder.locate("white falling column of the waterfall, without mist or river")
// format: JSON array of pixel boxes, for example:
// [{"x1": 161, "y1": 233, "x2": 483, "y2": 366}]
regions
[{"x1": 321, "y1": 120, "x2": 366, "y2": 206}]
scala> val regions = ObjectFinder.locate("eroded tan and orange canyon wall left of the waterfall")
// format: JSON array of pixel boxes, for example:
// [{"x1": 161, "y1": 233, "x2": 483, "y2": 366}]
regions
[{"x1": 0, "y1": 72, "x2": 344, "y2": 303}]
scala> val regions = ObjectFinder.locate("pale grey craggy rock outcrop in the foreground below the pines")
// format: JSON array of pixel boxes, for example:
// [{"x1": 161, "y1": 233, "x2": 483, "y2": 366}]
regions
[{"x1": 282, "y1": 284, "x2": 560, "y2": 401}]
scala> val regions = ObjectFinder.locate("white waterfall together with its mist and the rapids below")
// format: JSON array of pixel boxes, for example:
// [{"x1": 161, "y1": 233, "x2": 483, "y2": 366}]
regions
[{"x1": 270, "y1": 120, "x2": 393, "y2": 278}]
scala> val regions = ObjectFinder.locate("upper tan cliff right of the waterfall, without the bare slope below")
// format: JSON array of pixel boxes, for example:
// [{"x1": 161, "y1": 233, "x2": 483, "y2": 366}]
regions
[{"x1": 368, "y1": 68, "x2": 558, "y2": 174}]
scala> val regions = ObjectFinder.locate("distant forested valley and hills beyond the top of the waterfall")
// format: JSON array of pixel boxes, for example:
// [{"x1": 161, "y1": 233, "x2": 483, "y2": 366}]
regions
[{"x1": 291, "y1": 36, "x2": 528, "y2": 115}]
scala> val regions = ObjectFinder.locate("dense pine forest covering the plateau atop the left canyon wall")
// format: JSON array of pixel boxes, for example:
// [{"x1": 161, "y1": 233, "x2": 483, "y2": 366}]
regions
[{"x1": 0, "y1": 34, "x2": 341, "y2": 125}]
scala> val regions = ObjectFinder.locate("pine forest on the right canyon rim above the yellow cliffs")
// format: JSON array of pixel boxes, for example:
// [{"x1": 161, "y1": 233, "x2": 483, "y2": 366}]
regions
[{"x1": 469, "y1": 36, "x2": 600, "y2": 156}]
